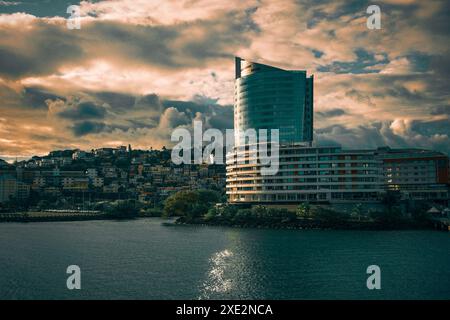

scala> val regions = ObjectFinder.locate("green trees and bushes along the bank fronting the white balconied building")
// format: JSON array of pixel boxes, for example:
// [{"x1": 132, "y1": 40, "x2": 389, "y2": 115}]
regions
[{"x1": 163, "y1": 190, "x2": 442, "y2": 230}]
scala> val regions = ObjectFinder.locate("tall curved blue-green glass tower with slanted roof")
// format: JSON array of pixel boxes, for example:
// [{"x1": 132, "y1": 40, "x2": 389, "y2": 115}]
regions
[{"x1": 234, "y1": 57, "x2": 313, "y2": 145}]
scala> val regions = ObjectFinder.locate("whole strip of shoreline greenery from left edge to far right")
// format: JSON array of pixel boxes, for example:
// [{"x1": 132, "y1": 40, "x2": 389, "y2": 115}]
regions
[{"x1": 0, "y1": 190, "x2": 446, "y2": 230}]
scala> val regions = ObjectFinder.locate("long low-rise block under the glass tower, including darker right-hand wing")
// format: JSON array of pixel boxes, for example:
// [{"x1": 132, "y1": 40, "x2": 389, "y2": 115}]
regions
[{"x1": 226, "y1": 145, "x2": 449, "y2": 203}]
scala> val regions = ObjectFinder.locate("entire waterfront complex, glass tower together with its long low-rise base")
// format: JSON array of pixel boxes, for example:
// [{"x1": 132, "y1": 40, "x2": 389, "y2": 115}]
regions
[{"x1": 226, "y1": 58, "x2": 450, "y2": 204}]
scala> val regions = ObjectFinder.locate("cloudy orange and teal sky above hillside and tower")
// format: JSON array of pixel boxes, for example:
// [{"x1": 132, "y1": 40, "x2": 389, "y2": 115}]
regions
[{"x1": 0, "y1": 0, "x2": 450, "y2": 160}]
